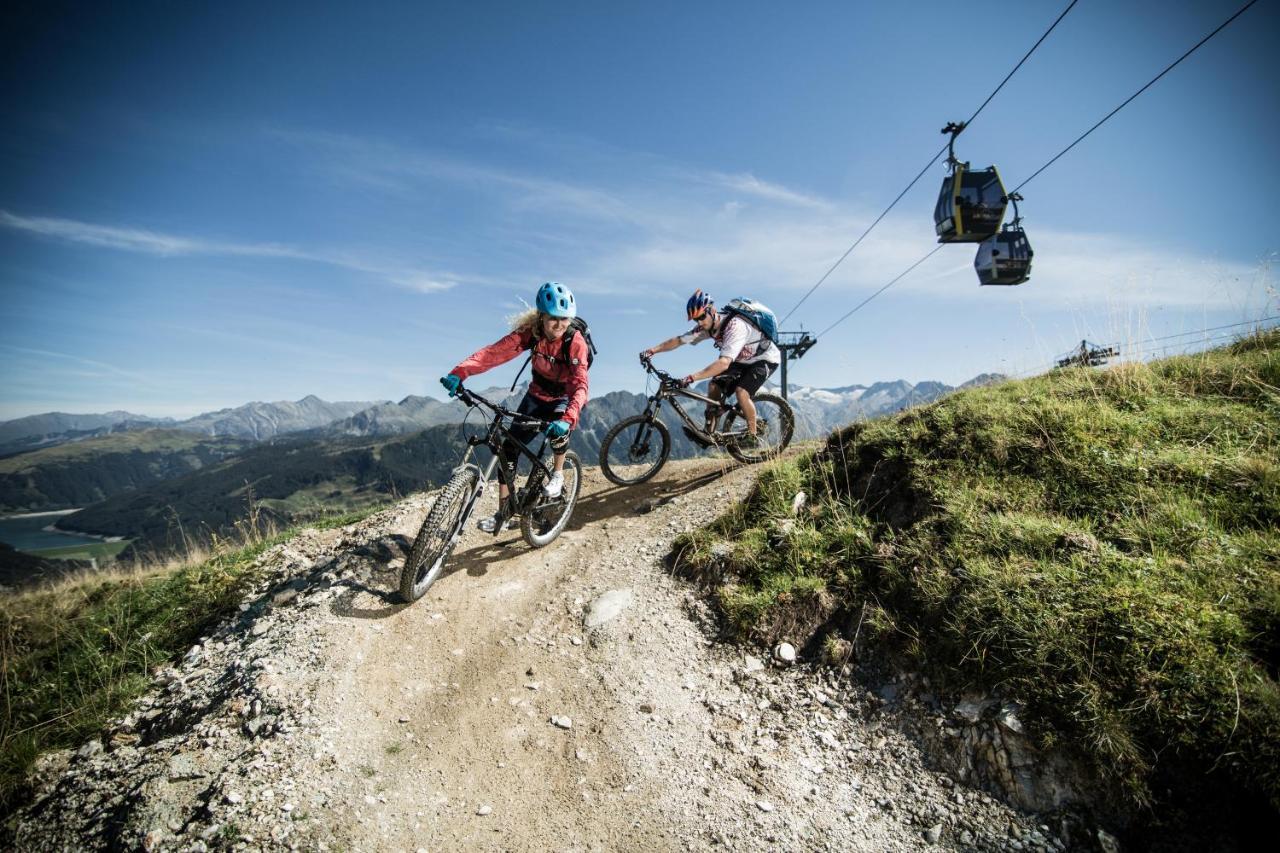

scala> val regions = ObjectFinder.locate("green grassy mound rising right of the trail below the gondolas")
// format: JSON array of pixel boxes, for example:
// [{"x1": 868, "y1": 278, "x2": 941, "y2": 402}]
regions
[{"x1": 678, "y1": 330, "x2": 1280, "y2": 807}]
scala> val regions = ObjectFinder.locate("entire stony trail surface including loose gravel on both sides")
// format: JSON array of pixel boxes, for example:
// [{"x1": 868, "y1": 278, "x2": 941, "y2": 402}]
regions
[{"x1": 17, "y1": 460, "x2": 1114, "y2": 852}]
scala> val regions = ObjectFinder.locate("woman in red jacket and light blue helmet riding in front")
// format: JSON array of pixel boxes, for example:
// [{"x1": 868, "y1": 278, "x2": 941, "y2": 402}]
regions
[{"x1": 440, "y1": 282, "x2": 588, "y2": 533}]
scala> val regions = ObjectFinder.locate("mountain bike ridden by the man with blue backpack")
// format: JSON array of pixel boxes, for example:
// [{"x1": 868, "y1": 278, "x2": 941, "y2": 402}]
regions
[{"x1": 600, "y1": 359, "x2": 796, "y2": 485}]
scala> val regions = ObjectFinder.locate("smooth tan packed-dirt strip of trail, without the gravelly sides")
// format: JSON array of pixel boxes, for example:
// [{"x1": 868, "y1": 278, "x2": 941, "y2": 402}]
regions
[{"x1": 295, "y1": 462, "x2": 751, "y2": 849}]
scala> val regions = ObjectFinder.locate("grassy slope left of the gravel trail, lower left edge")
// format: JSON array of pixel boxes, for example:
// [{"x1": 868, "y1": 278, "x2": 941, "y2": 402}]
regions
[{"x1": 0, "y1": 511, "x2": 371, "y2": 815}]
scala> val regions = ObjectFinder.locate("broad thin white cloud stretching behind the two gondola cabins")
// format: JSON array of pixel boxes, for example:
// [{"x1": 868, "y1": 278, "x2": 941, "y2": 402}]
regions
[{"x1": 278, "y1": 128, "x2": 1249, "y2": 314}]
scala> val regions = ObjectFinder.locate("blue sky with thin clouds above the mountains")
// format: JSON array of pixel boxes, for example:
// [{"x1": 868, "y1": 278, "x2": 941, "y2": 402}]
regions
[{"x1": 0, "y1": 0, "x2": 1280, "y2": 418}]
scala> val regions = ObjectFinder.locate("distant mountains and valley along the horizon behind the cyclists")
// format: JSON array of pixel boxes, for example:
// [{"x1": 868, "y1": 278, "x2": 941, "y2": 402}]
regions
[{"x1": 0, "y1": 375, "x2": 1002, "y2": 563}]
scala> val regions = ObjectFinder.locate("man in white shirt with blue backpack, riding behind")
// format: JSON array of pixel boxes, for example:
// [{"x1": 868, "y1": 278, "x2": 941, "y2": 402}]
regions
[{"x1": 640, "y1": 289, "x2": 782, "y2": 447}]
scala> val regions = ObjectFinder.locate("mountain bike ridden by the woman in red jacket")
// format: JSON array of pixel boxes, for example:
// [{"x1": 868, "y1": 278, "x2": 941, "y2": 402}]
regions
[{"x1": 401, "y1": 386, "x2": 582, "y2": 603}]
